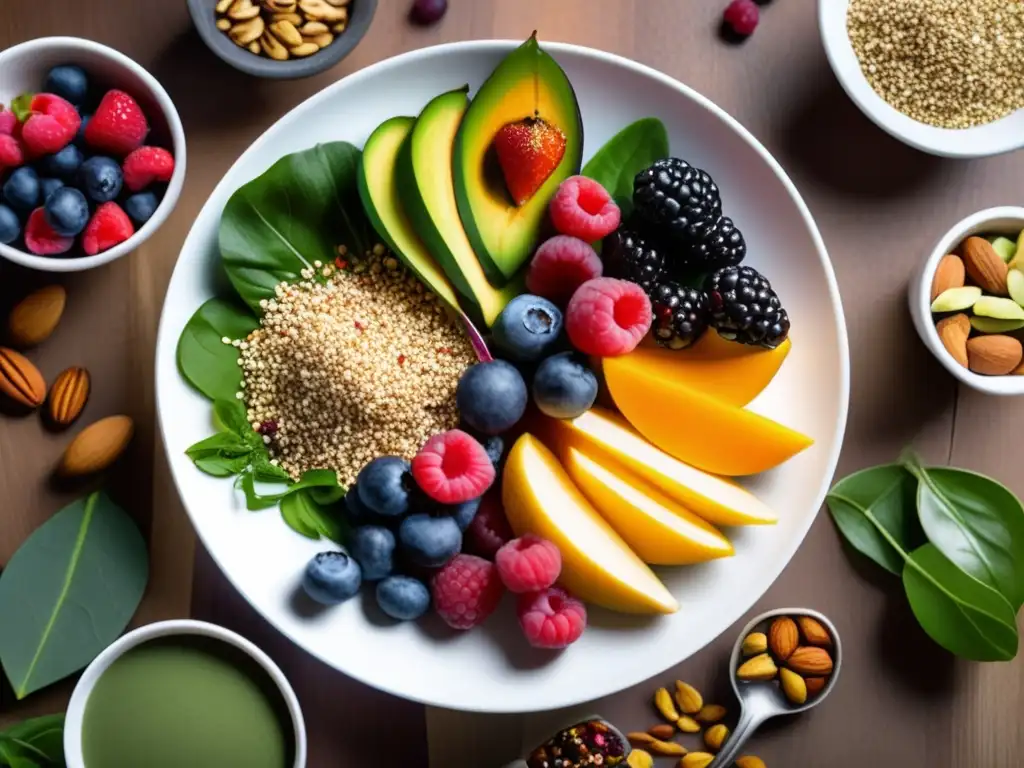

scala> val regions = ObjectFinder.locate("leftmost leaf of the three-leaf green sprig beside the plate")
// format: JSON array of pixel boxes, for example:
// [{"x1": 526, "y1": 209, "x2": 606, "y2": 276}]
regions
[{"x1": 825, "y1": 464, "x2": 925, "y2": 575}]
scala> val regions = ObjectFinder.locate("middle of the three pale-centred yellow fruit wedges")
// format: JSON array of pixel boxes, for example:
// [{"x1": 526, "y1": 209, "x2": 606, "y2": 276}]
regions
[{"x1": 562, "y1": 449, "x2": 733, "y2": 565}]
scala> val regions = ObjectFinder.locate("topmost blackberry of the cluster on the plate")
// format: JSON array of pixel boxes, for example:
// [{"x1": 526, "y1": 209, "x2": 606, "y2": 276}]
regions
[{"x1": 633, "y1": 158, "x2": 722, "y2": 240}]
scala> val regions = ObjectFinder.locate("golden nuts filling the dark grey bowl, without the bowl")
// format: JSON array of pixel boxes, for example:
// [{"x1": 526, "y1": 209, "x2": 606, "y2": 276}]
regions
[{"x1": 215, "y1": 0, "x2": 351, "y2": 61}]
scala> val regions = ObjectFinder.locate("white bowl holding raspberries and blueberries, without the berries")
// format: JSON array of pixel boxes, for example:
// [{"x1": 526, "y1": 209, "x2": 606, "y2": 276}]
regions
[{"x1": 0, "y1": 37, "x2": 185, "y2": 272}]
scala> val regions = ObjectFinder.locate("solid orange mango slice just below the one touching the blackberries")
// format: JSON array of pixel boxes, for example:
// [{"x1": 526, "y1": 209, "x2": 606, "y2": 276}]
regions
[{"x1": 602, "y1": 355, "x2": 813, "y2": 476}]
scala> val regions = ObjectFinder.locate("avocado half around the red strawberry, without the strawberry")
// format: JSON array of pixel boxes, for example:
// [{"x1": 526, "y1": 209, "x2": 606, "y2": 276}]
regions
[{"x1": 454, "y1": 33, "x2": 583, "y2": 286}]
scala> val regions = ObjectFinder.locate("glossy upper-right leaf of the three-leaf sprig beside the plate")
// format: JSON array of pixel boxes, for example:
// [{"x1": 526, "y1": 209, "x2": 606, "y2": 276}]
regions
[{"x1": 904, "y1": 457, "x2": 1024, "y2": 610}]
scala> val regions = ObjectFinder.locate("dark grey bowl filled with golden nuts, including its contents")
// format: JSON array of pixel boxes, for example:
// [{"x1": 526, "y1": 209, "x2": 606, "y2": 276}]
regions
[{"x1": 188, "y1": 0, "x2": 377, "y2": 79}]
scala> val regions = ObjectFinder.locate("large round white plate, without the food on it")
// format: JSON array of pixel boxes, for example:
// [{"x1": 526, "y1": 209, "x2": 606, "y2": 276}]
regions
[{"x1": 157, "y1": 41, "x2": 849, "y2": 713}]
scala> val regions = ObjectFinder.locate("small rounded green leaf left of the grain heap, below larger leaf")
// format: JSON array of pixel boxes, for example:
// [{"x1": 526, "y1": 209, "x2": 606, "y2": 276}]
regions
[{"x1": 178, "y1": 299, "x2": 259, "y2": 400}]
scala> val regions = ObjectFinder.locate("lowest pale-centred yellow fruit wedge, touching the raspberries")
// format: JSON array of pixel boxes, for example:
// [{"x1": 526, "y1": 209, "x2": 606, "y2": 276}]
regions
[{"x1": 502, "y1": 434, "x2": 679, "y2": 613}]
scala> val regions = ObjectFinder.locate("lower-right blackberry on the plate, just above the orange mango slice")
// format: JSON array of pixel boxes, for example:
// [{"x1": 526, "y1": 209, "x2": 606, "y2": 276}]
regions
[{"x1": 705, "y1": 266, "x2": 790, "y2": 349}]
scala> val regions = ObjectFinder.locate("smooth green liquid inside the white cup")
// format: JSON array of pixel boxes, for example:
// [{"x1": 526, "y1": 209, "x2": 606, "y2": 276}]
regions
[{"x1": 82, "y1": 636, "x2": 294, "y2": 768}]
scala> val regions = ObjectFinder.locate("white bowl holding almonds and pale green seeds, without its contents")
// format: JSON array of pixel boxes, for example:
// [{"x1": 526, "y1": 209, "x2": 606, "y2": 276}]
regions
[{"x1": 909, "y1": 206, "x2": 1024, "y2": 394}]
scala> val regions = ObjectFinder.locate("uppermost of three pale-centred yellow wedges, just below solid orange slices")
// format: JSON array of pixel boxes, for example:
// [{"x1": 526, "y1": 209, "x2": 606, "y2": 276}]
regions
[{"x1": 540, "y1": 408, "x2": 777, "y2": 525}]
